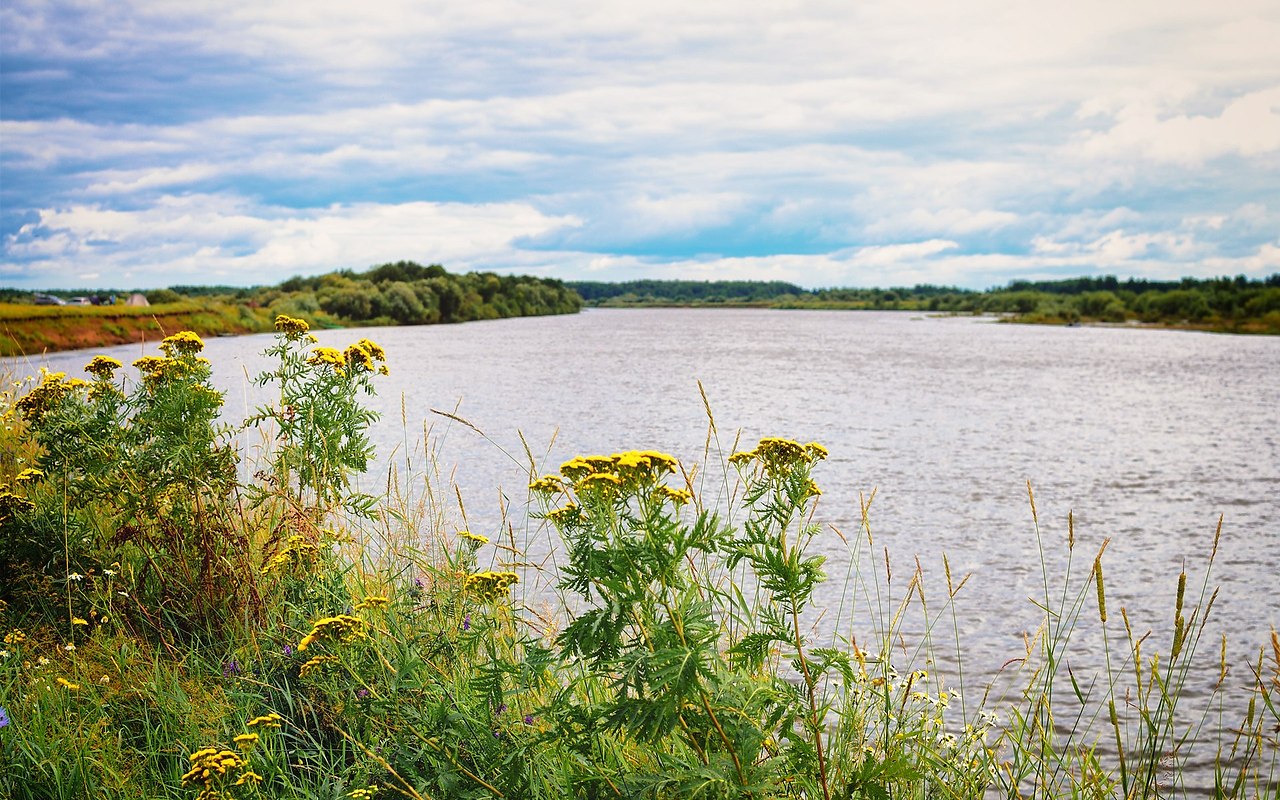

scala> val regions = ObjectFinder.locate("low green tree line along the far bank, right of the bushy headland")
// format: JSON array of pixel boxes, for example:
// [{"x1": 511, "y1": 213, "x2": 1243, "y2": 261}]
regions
[{"x1": 566, "y1": 273, "x2": 1280, "y2": 334}]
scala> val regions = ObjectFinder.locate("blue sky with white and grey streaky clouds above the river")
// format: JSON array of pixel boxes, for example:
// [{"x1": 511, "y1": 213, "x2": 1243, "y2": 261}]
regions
[{"x1": 0, "y1": 0, "x2": 1280, "y2": 289}]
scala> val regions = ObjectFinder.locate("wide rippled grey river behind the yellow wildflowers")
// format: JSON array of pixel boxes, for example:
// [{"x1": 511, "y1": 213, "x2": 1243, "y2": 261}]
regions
[{"x1": 17, "y1": 310, "x2": 1280, "y2": 790}]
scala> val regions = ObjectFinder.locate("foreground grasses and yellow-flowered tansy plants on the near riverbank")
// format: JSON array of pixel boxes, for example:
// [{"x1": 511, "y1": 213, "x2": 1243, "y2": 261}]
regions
[{"x1": 0, "y1": 315, "x2": 1280, "y2": 800}]
